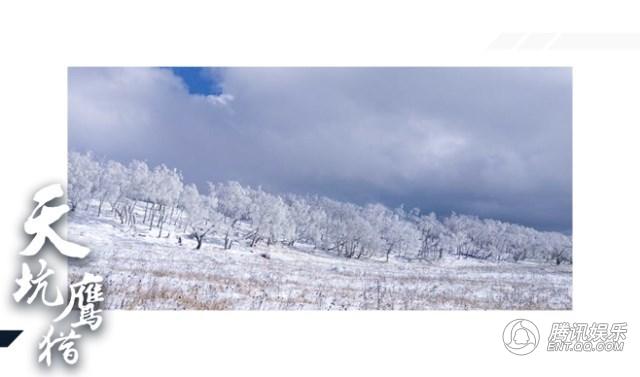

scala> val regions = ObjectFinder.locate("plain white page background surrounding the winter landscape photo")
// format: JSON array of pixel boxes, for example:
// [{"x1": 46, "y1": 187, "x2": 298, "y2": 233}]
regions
[{"x1": 0, "y1": 0, "x2": 640, "y2": 376}]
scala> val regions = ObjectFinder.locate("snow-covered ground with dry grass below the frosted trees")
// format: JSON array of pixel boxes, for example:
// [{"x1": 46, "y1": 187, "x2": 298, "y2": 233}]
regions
[{"x1": 68, "y1": 212, "x2": 572, "y2": 310}]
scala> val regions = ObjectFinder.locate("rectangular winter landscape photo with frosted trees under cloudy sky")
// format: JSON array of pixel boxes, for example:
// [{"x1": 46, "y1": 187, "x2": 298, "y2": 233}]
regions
[{"x1": 66, "y1": 67, "x2": 573, "y2": 310}]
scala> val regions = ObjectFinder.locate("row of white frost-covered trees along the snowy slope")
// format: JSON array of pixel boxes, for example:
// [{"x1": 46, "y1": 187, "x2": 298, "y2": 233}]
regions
[{"x1": 68, "y1": 152, "x2": 572, "y2": 264}]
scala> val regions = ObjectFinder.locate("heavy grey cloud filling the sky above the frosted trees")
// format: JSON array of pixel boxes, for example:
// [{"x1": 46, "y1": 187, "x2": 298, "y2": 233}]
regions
[{"x1": 69, "y1": 68, "x2": 572, "y2": 231}]
